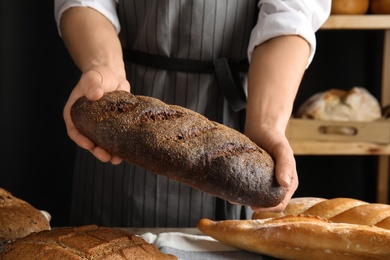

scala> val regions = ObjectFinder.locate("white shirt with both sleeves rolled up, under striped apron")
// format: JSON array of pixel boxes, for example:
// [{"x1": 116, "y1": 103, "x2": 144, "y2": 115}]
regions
[{"x1": 54, "y1": 0, "x2": 332, "y2": 66}]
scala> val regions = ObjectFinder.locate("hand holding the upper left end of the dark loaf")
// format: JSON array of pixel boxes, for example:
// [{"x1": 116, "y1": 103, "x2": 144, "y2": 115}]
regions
[{"x1": 63, "y1": 66, "x2": 130, "y2": 164}]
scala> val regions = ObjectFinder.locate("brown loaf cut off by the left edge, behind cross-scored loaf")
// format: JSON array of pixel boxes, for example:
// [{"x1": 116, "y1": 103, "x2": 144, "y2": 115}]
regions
[{"x1": 0, "y1": 188, "x2": 50, "y2": 245}]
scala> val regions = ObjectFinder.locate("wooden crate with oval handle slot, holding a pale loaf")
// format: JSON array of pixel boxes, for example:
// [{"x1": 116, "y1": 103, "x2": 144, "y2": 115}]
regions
[{"x1": 286, "y1": 118, "x2": 390, "y2": 144}]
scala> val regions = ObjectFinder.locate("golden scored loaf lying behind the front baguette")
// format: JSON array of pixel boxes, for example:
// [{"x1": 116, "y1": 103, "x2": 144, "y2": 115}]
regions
[{"x1": 252, "y1": 198, "x2": 390, "y2": 230}]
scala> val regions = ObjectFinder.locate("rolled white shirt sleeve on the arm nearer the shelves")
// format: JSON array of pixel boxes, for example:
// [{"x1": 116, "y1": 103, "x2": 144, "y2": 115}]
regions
[{"x1": 248, "y1": 0, "x2": 332, "y2": 66}]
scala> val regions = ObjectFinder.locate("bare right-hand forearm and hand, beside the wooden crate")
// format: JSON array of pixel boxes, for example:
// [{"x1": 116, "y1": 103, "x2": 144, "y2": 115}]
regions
[{"x1": 245, "y1": 36, "x2": 310, "y2": 211}]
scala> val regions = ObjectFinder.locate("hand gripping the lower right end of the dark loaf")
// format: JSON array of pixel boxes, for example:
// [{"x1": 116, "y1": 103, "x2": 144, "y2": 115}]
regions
[{"x1": 245, "y1": 127, "x2": 298, "y2": 212}]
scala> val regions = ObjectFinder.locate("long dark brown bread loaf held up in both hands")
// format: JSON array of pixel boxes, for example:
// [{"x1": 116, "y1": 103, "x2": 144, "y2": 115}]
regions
[{"x1": 71, "y1": 91, "x2": 286, "y2": 207}]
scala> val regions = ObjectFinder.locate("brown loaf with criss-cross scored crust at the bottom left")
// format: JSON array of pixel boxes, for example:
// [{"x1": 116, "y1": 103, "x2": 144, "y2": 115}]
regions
[{"x1": 0, "y1": 225, "x2": 177, "y2": 260}]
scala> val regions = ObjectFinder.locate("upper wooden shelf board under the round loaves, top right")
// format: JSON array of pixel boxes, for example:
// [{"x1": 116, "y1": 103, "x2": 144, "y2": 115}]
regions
[{"x1": 321, "y1": 14, "x2": 390, "y2": 30}]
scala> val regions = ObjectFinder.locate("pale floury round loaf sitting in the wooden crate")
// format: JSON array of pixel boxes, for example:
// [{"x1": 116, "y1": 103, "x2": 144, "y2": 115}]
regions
[{"x1": 295, "y1": 87, "x2": 382, "y2": 121}]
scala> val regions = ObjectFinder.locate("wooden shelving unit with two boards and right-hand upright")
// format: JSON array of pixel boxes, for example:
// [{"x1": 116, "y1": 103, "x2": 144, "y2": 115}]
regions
[{"x1": 289, "y1": 15, "x2": 390, "y2": 203}]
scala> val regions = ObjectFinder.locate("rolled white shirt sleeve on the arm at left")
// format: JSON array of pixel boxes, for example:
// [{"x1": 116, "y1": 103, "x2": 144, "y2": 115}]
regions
[{"x1": 54, "y1": 0, "x2": 120, "y2": 35}]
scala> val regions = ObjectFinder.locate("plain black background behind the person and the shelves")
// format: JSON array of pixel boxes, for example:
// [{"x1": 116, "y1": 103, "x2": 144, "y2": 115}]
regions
[{"x1": 0, "y1": 0, "x2": 383, "y2": 226}]
